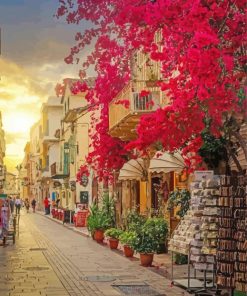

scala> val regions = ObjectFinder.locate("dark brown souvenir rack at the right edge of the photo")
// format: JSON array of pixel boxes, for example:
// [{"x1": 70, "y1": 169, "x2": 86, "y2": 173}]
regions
[{"x1": 216, "y1": 174, "x2": 247, "y2": 295}]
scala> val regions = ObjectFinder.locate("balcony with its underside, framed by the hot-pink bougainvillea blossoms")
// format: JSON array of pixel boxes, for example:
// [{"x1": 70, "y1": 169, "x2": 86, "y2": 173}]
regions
[{"x1": 109, "y1": 81, "x2": 164, "y2": 141}]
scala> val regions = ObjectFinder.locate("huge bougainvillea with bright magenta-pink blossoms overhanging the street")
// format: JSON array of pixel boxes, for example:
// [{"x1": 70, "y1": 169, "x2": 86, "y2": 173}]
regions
[{"x1": 57, "y1": 0, "x2": 247, "y2": 173}]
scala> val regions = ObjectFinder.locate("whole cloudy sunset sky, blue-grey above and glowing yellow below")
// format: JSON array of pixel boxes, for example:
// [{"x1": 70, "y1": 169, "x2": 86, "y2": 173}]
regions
[{"x1": 0, "y1": 0, "x2": 85, "y2": 170}]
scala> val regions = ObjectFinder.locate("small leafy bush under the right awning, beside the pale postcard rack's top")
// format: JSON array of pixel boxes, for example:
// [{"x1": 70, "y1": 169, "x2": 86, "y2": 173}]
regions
[{"x1": 167, "y1": 189, "x2": 191, "y2": 218}]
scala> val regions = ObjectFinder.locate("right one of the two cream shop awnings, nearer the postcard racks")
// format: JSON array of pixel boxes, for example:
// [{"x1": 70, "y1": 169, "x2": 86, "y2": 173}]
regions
[{"x1": 149, "y1": 152, "x2": 185, "y2": 173}]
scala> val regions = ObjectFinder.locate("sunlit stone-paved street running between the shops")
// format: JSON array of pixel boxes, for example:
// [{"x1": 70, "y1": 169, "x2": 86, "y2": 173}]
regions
[{"x1": 0, "y1": 213, "x2": 189, "y2": 296}]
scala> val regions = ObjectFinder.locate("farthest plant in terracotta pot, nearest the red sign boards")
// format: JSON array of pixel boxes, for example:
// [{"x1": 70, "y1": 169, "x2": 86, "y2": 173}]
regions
[{"x1": 87, "y1": 209, "x2": 109, "y2": 243}]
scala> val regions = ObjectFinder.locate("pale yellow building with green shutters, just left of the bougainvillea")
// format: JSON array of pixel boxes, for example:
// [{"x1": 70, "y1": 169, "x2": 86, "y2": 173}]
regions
[{"x1": 51, "y1": 78, "x2": 95, "y2": 210}]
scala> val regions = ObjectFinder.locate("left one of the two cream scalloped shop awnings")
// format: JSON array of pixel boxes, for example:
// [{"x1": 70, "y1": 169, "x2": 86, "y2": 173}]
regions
[{"x1": 118, "y1": 158, "x2": 147, "y2": 181}]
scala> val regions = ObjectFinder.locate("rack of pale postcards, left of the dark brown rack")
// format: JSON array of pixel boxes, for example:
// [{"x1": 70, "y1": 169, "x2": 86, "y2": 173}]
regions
[{"x1": 169, "y1": 172, "x2": 219, "y2": 295}]
